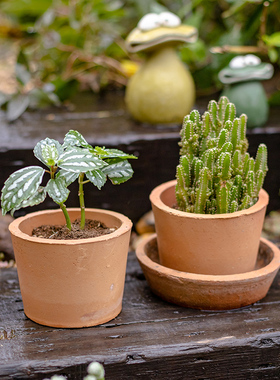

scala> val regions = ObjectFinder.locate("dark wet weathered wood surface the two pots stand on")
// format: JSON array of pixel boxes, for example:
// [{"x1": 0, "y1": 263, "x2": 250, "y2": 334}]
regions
[{"x1": 0, "y1": 246, "x2": 280, "y2": 380}]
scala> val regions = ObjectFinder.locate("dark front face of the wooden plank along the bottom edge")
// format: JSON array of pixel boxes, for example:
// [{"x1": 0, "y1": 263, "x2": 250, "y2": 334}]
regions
[{"x1": 3, "y1": 336, "x2": 280, "y2": 380}]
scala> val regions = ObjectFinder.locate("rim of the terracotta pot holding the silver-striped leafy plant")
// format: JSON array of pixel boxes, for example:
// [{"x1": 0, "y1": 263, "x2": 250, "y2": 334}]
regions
[{"x1": 9, "y1": 207, "x2": 132, "y2": 245}]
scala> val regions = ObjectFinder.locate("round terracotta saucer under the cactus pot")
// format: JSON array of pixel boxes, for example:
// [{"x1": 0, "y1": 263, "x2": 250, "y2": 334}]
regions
[{"x1": 136, "y1": 234, "x2": 280, "y2": 310}]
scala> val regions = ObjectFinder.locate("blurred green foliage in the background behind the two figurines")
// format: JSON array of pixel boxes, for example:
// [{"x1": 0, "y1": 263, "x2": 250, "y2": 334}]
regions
[{"x1": 0, "y1": 0, "x2": 280, "y2": 120}]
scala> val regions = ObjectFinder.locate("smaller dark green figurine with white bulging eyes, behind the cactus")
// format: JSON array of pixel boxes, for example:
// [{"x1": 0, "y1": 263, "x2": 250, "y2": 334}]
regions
[{"x1": 219, "y1": 54, "x2": 273, "y2": 128}]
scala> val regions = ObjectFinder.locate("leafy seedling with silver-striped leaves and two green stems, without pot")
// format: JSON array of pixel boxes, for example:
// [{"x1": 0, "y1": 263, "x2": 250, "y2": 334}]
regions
[{"x1": 1, "y1": 130, "x2": 137, "y2": 230}]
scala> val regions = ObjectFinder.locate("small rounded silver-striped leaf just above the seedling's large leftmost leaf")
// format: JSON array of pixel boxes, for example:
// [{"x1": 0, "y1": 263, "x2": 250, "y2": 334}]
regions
[{"x1": 34, "y1": 137, "x2": 63, "y2": 167}]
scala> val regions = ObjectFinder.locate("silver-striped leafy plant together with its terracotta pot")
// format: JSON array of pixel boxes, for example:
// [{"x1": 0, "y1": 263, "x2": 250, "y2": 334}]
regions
[{"x1": 1, "y1": 130, "x2": 136, "y2": 327}]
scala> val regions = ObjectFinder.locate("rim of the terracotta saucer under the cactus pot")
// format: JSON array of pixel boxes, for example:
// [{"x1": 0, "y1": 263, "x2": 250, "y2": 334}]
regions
[{"x1": 136, "y1": 233, "x2": 280, "y2": 285}]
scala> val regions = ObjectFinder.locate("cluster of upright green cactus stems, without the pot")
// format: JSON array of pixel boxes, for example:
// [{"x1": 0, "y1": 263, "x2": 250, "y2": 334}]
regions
[{"x1": 176, "y1": 96, "x2": 267, "y2": 214}]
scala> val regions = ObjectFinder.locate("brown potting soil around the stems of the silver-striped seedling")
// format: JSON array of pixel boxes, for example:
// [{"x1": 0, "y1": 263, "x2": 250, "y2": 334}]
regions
[{"x1": 32, "y1": 219, "x2": 116, "y2": 240}]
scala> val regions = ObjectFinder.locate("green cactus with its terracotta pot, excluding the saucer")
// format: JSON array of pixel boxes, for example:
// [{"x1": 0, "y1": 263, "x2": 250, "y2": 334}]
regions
[{"x1": 150, "y1": 97, "x2": 268, "y2": 275}]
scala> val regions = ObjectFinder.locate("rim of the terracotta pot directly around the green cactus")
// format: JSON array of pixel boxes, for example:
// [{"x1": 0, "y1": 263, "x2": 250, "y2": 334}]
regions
[{"x1": 150, "y1": 179, "x2": 269, "y2": 219}]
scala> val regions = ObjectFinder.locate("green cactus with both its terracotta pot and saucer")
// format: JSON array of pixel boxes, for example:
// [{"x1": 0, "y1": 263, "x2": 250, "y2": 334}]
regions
[{"x1": 136, "y1": 97, "x2": 279, "y2": 309}]
